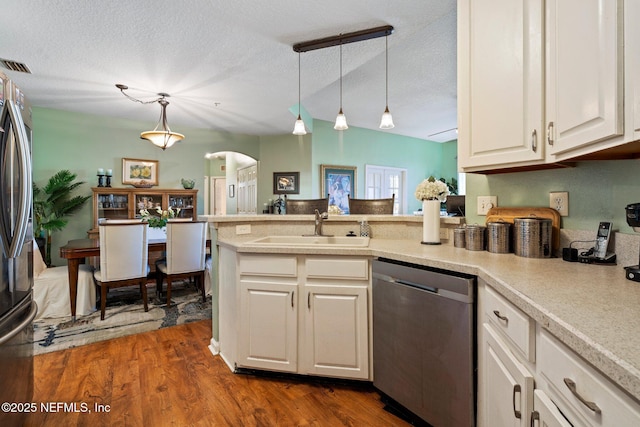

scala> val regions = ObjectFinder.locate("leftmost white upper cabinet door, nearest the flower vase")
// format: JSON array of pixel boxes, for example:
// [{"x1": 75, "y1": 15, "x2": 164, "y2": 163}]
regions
[{"x1": 458, "y1": 0, "x2": 545, "y2": 171}]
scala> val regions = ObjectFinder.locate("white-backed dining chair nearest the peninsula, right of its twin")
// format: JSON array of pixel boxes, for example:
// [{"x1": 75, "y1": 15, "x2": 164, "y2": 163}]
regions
[{"x1": 156, "y1": 221, "x2": 207, "y2": 307}]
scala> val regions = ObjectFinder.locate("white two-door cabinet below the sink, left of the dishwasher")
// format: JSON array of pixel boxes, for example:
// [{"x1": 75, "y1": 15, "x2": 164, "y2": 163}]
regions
[{"x1": 236, "y1": 254, "x2": 371, "y2": 379}]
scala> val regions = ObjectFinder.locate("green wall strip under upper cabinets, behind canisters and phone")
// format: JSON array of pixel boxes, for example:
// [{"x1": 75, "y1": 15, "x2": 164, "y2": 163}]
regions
[{"x1": 467, "y1": 160, "x2": 640, "y2": 233}]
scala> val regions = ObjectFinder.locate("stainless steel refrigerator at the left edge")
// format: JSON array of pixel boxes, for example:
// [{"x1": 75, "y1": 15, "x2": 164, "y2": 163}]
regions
[{"x1": 0, "y1": 73, "x2": 37, "y2": 425}]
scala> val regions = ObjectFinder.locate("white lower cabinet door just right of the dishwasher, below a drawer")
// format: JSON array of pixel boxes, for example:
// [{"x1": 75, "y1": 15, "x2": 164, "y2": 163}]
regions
[{"x1": 479, "y1": 324, "x2": 533, "y2": 427}]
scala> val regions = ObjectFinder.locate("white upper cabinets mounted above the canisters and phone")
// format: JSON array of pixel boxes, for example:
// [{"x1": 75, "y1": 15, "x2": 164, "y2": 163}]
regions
[{"x1": 458, "y1": 0, "x2": 640, "y2": 172}]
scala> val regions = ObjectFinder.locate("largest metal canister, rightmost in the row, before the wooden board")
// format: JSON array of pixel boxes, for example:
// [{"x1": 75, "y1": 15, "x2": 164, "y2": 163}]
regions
[{"x1": 513, "y1": 218, "x2": 552, "y2": 258}]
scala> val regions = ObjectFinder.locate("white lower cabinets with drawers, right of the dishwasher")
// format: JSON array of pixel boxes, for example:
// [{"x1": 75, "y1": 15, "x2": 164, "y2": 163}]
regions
[{"x1": 477, "y1": 279, "x2": 640, "y2": 427}]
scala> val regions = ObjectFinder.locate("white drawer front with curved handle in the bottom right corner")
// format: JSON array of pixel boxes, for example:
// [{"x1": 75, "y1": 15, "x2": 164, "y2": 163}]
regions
[{"x1": 538, "y1": 330, "x2": 640, "y2": 426}]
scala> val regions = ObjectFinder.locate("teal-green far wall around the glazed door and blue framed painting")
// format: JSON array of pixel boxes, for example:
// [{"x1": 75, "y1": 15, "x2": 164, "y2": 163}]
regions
[{"x1": 311, "y1": 120, "x2": 450, "y2": 212}]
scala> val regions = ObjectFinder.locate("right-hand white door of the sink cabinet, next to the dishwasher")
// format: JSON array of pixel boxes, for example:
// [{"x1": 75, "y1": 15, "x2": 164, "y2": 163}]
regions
[{"x1": 301, "y1": 285, "x2": 369, "y2": 379}]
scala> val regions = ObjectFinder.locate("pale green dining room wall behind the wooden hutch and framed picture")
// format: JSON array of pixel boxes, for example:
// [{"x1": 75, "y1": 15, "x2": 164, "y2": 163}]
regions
[{"x1": 33, "y1": 107, "x2": 260, "y2": 265}]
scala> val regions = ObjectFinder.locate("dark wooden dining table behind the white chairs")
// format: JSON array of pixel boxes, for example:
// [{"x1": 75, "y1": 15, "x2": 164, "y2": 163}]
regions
[{"x1": 60, "y1": 239, "x2": 211, "y2": 320}]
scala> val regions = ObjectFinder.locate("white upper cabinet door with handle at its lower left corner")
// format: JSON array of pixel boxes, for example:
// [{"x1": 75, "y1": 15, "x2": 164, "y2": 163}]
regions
[{"x1": 546, "y1": 0, "x2": 624, "y2": 157}]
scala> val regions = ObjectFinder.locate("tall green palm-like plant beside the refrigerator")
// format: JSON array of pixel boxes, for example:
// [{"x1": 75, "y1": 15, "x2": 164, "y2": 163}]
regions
[{"x1": 33, "y1": 170, "x2": 91, "y2": 266}]
